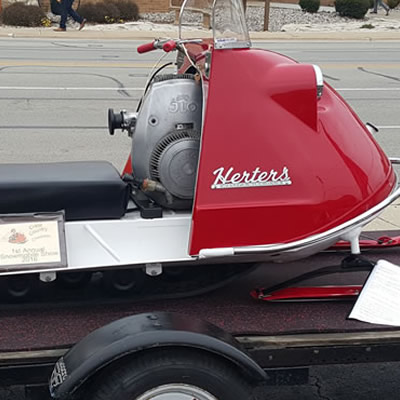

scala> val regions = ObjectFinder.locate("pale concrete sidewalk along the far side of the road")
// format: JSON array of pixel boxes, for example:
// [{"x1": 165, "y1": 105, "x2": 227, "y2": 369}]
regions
[{"x1": 0, "y1": 2, "x2": 400, "y2": 40}]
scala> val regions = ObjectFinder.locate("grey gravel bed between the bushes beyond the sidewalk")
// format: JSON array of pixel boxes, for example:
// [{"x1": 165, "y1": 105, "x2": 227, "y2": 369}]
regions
[{"x1": 140, "y1": 6, "x2": 350, "y2": 32}]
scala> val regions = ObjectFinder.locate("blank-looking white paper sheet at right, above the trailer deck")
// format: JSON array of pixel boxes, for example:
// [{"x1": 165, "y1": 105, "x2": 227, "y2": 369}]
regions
[{"x1": 349, "y1": 260, "x2": 400, "y2": 326}]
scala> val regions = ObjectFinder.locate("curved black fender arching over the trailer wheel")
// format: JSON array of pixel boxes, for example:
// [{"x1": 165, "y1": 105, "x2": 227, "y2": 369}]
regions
[{"x1": 50, "y1": 312, "x2": 267, "y2": 399}]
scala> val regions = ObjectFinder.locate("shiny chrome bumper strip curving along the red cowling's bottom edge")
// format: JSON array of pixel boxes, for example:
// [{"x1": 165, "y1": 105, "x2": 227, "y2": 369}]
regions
[{"x1": 199, "y1": 163, "x2": 400, "y2": 258}]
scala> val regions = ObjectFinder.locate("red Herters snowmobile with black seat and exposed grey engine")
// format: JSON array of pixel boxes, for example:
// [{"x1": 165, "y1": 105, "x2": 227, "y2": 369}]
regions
[{"x1": 0, "y1": 0, "x2": 400, "y2": 297}]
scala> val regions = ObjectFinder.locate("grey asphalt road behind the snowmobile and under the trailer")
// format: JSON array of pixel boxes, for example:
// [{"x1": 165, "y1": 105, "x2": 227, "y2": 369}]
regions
[{"x1": 0, "y1": 38, "x2": 400, "y2": 400}]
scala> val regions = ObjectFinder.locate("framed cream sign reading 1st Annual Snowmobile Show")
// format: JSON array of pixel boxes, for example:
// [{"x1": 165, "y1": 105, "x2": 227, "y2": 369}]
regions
[{"x1": 0, "y1": 220, "x2": 61, "y2": 267}]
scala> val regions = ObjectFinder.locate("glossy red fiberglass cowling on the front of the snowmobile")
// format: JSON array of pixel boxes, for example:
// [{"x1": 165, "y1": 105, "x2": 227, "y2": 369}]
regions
[{"x1": 189, "y1": 49, "x2": 396, "y2": 255}]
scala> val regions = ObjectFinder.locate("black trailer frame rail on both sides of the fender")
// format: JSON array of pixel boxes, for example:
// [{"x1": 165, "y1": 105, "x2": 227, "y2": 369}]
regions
[{"x1": 0, "y1": 316, "x2": 400, "y2": 400}]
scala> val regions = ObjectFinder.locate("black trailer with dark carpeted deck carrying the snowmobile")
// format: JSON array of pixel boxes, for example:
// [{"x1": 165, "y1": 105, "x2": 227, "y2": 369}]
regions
[{"x1": 0, "y1": 241, "x2": 400, "y2": 400}]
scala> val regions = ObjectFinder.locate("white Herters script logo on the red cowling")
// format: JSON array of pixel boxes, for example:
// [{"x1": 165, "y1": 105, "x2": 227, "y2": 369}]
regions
[{"x1": 211, "y1": 166, "x2": 292, "y2": 189}]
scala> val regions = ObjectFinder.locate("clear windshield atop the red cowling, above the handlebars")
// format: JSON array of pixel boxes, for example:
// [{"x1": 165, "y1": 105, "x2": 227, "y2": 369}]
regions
[{"x1": 178, "y1": 0, "x2": 251, "y2": 49}]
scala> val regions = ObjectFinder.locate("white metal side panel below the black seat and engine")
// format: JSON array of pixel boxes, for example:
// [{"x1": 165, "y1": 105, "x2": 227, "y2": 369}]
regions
[{"x1": 0, "y1": 211, "x2": 196, "y2": 276}]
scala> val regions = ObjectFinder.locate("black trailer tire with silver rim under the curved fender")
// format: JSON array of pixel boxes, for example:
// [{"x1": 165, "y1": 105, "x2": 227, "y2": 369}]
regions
[{"x1": 90, "y1": 349, "x2": 253, "y2": 400}]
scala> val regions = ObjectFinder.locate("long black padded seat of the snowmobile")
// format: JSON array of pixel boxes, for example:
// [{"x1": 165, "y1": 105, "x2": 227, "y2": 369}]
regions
[{"x1": 0, "y1": 161, "x2": 129, "y2": 221}]
